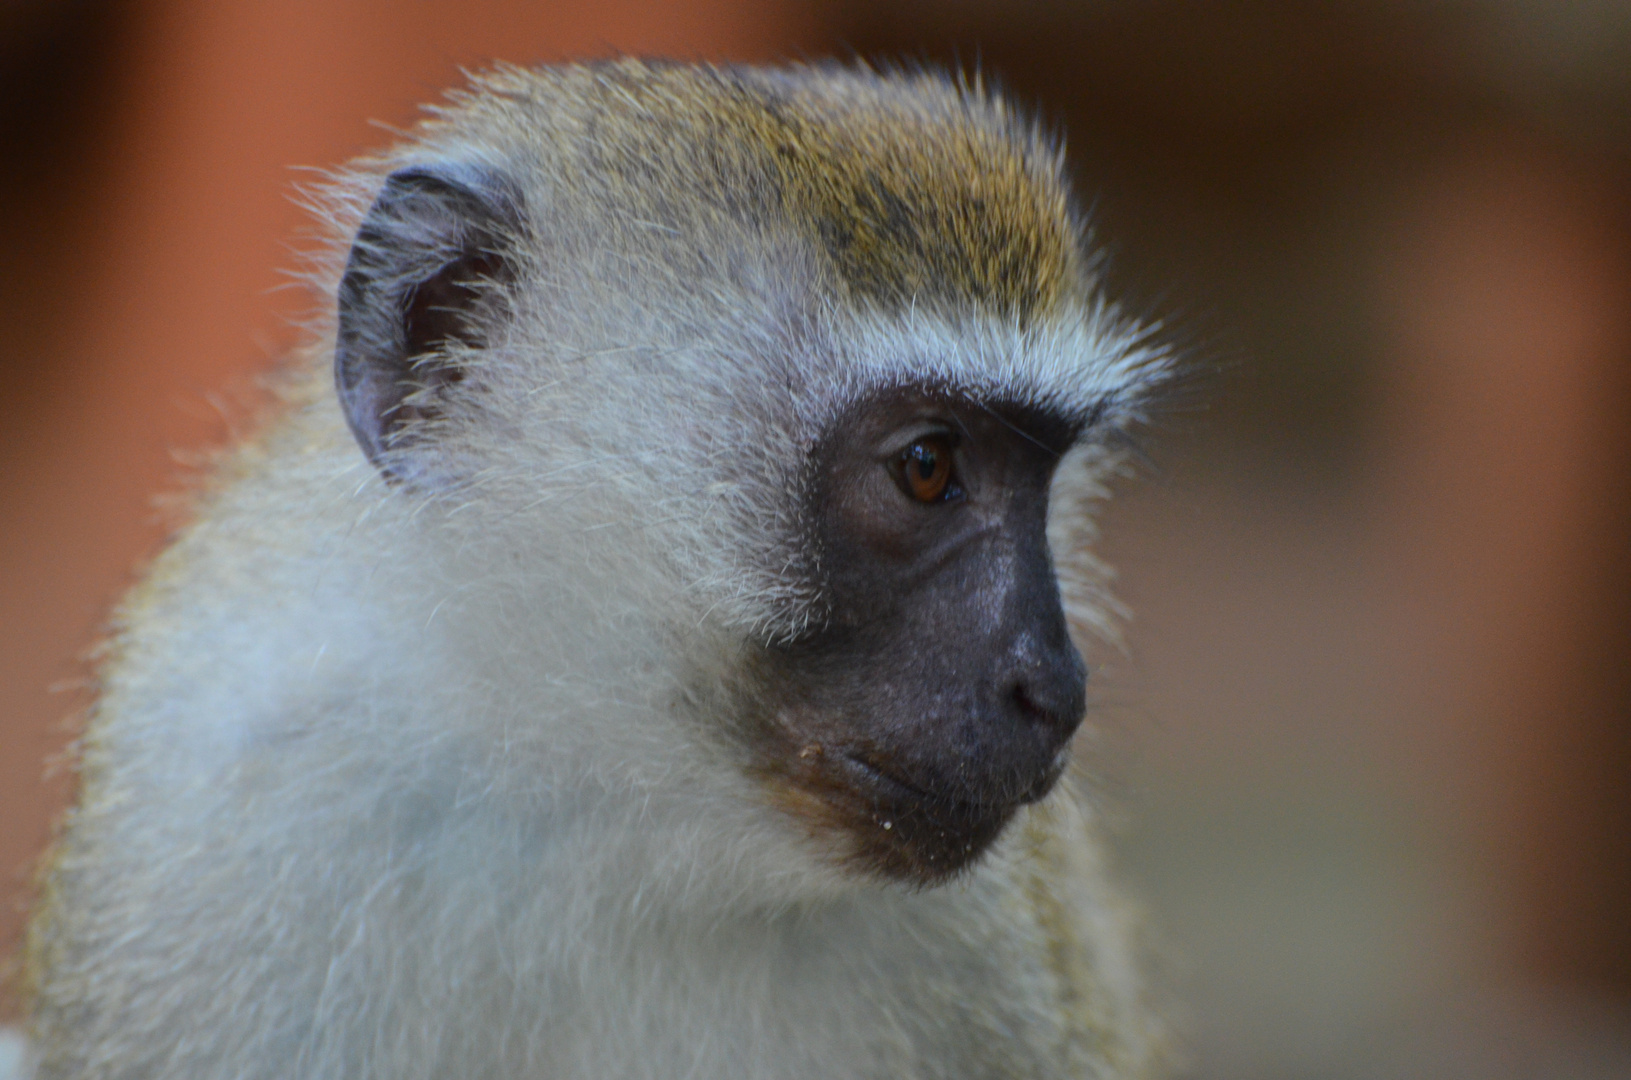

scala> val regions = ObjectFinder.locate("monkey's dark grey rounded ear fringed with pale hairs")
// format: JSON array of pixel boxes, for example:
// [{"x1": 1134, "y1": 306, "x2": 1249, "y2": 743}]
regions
[{"x1": 334, "y1": 165, "x2": 519, "y2": 480}]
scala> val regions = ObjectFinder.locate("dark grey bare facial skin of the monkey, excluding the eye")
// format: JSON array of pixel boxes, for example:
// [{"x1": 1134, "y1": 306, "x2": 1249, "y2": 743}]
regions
[{"x1": 756, "y1": 390, "x2": 1088, "y2": 884}]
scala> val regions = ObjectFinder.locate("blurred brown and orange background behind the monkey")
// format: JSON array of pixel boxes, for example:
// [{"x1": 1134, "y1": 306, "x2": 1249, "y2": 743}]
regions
[{"x1": 0, "y1": 0, "x2": 1631, "y2": 1080}]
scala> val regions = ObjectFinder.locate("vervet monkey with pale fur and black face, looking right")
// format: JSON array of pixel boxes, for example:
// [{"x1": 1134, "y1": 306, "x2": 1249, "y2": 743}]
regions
[{"x1": 28, "y1": 60, "x2": 1166, "y2": 1080}]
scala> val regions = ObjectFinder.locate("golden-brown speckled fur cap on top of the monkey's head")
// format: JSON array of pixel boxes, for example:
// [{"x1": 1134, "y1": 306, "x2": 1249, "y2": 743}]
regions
[{"x1": 432, "y1": 60, "x2": 1085, "y2": 321}]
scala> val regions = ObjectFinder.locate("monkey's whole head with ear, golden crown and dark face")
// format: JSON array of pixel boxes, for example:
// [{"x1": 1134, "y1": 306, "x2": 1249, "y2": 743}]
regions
[{"x1": 327, "y1": 62, "x2": 1165, "y2": 884}]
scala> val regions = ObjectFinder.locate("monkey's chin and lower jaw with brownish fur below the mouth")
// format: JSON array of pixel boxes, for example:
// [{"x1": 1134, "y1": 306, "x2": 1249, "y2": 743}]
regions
[{"x1": 768, "y1": 746, "x2": 1070, "y2": 889}]
